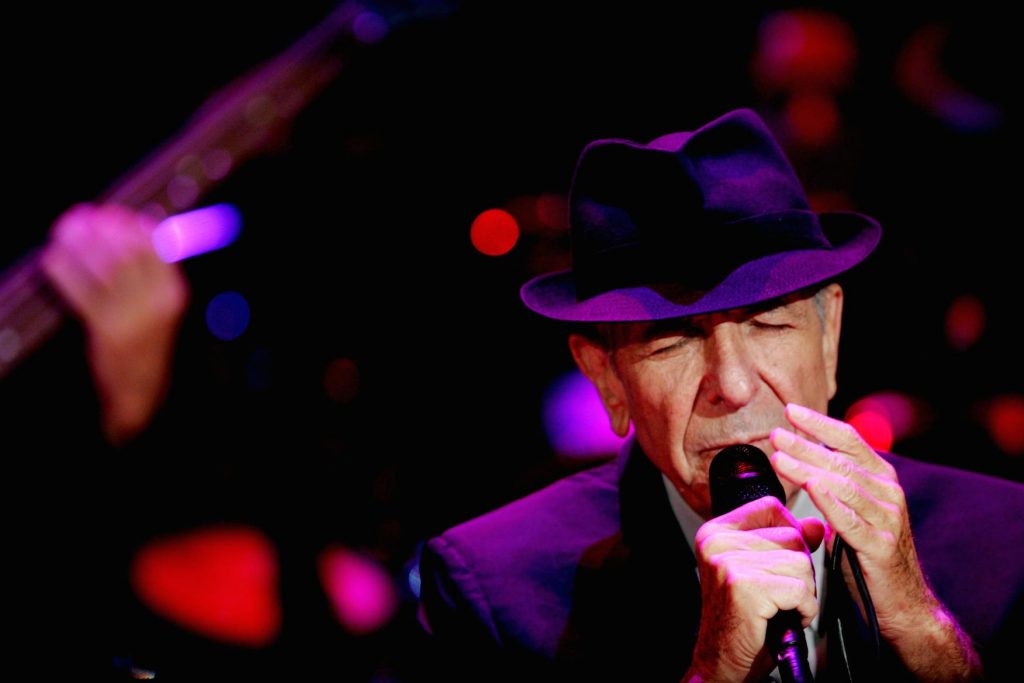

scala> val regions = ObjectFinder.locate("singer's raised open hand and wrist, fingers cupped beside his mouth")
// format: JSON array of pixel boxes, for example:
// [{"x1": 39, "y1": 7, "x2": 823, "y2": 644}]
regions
[{"x1": 771, "y1": 403, "x2": 979, "y2": 680}]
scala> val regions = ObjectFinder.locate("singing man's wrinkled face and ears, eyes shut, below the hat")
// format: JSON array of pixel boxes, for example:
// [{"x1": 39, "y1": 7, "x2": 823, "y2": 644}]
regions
[{"x1": 569, "y1": 285, "x2": 843, "y2": 518}]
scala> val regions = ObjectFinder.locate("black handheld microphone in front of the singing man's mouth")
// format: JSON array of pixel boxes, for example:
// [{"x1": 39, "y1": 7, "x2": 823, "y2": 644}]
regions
[{"x1": 709, "y1": 443, "x2": 814, "y2": 683}]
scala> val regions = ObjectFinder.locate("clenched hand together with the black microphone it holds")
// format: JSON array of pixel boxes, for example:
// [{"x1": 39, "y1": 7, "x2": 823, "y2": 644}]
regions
[{"x1": 690, "y1": 445, "x2": 824, "y2": 681}]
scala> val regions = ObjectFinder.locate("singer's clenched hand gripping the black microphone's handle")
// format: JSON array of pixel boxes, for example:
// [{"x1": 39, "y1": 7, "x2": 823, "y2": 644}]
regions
[{"x1": 683, "y1": 497, "x2": 824, "y2": 681}]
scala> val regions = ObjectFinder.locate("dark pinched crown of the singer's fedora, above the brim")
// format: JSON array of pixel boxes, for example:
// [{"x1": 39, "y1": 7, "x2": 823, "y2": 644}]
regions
[{"x1": 569, "y1": 110, "x2": 828, "y2": 298}]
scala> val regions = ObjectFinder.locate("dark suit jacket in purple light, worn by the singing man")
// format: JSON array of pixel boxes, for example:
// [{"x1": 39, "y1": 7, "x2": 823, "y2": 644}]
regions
[{"x1": 420, "y1": 441, "x2": 1024, "y2": 682}]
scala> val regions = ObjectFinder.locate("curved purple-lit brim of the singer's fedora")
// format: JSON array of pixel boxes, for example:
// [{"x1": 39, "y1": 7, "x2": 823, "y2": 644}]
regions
[{"x1": 519, "y1": 211, "x2": 882, "y2": 323}]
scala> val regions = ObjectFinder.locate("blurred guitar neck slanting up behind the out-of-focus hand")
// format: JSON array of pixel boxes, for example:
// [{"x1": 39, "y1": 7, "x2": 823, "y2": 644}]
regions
[{"x1": 0, "y1": 2, "x2": 418, "y2": 379}]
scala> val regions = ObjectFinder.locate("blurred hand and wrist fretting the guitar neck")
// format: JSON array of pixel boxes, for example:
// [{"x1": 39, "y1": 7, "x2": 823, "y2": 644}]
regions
[{"x1": 42, "y1": 204, "x2": 188, "y2": 443}]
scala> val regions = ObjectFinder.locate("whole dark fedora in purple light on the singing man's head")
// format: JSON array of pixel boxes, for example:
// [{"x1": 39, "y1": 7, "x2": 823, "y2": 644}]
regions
[{"x1": 520, "y1": 109, "x2": 882, "y2": 323}]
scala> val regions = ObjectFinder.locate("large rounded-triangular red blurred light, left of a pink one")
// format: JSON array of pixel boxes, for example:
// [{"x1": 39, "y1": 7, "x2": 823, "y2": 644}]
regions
[{"x1": 131, "y1": 526, "x2": 281, "y2": 647}]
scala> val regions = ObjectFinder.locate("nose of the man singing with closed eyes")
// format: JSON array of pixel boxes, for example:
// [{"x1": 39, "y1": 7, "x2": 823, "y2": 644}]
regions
[{"x1": 701, "y1": 322, "x2": 758, "y2": 411}]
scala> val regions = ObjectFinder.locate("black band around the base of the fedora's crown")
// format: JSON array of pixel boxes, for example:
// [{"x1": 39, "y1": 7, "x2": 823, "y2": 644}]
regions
[{"x1": 572, "y1": 209, "x2": 833, "y2": 301}]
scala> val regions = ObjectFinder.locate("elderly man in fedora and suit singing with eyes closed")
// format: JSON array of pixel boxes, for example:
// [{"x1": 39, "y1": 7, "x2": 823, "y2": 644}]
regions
[{"x1": 421, "y1": 110, "x2": 1024, "y2": 681}]
